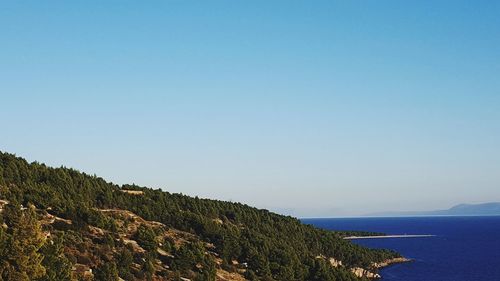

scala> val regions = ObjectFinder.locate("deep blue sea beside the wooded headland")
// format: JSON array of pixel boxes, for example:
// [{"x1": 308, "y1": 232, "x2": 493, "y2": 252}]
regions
[{"x1": 302, "y1": 216, "x2": 500, "y2": 281}]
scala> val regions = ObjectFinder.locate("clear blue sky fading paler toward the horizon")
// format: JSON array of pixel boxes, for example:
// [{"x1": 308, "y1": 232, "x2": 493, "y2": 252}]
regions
[{"x1": 0, "y1": 0, "x2": 500, "y2": 216}]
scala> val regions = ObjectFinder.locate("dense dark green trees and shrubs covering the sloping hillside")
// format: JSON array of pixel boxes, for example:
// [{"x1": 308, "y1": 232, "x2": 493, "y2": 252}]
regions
[{"x1": 0, "y1": 152, "x2": 397, "y2": 281}]
